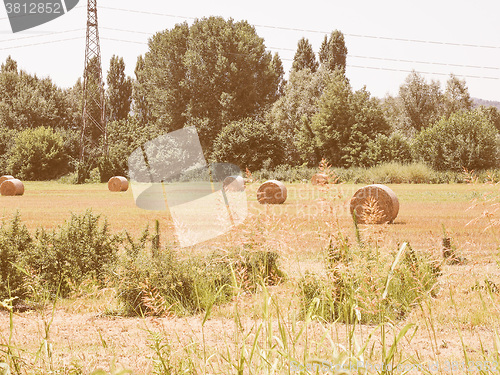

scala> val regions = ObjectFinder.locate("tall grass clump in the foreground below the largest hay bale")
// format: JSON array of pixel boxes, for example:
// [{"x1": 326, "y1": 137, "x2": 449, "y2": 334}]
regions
[{"x1": 299, "y1": 239, "x2": 440, "y2": 324}]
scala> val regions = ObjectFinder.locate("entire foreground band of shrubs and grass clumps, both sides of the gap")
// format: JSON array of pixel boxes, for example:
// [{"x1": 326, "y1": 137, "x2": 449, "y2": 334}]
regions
[{"x1": 0, "y1": 211, "x2": 446, "y2": 323}]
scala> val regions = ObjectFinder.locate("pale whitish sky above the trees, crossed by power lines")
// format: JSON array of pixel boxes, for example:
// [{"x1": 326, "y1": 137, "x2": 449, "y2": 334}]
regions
[{"x1": 0, "y1": 0, "x2": 500, "y2": 101}]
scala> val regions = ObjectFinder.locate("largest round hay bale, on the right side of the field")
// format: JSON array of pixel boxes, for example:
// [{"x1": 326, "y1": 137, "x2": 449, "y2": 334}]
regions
[{"x1": 350, "y1": 184, "x2": 399, "y2": 224}]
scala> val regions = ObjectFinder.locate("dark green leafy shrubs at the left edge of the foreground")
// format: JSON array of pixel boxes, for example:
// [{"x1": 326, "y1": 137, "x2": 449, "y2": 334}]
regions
[{"x1": 0, "y1": 210, "x2": 119, "y2": 298}]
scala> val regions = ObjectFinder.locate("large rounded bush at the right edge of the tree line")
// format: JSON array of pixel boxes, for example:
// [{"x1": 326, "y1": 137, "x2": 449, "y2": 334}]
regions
[{"x1": 413, "y1": 110, "x2": 498, "y2": 171}]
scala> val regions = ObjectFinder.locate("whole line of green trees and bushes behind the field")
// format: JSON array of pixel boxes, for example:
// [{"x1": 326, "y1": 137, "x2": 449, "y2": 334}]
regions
[{"x1": 0, "y1": 17, "x2": 500, "y2": 180}]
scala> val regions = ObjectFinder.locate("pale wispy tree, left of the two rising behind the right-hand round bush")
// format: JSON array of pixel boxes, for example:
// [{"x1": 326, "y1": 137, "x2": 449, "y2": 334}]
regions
[{"x1": 399, "y1": 71, "x2": 443, "y2": 134}]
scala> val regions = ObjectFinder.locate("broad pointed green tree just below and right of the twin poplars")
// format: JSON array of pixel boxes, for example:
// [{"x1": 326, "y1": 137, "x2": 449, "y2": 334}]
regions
[{"x1": 310, "y1": 70, "x2": 390, "y2": 167}]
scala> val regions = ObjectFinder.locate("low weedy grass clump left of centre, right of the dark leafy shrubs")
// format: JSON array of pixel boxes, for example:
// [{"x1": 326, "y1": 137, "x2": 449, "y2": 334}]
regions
[{"x1": 114, "y1": 228, "x2": 284, "y2": 316}]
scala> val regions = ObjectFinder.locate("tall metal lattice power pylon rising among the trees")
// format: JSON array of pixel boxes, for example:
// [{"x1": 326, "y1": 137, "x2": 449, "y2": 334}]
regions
[{"x1": 78, "y1": 0, "x2": 107, "y2": 182}]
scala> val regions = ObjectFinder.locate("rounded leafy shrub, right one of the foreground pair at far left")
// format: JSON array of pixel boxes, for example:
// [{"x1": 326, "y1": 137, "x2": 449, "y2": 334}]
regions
[{"x1": 26, "y1": 210, "x2": 119, "y2": 297}]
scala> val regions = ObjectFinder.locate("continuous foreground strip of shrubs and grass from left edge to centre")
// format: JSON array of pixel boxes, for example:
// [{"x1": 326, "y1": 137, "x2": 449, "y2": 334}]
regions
[{"x1": 0, "y1": 210, "x2": 284, "y2": 315}]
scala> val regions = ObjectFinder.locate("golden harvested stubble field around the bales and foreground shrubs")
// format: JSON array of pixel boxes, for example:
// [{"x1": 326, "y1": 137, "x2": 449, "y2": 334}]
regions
[{"x1": 0, "y1": 182, "x2": 500, "y2": 374}]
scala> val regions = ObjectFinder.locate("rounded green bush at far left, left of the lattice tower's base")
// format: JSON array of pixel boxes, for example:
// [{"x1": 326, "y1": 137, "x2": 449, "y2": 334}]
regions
[{"x1": 7, "y1": 126, "x2": 69, "y2": 181}]
